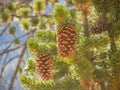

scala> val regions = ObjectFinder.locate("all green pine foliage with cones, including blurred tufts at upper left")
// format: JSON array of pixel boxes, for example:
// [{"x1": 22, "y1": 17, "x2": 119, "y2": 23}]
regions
[{"x1": 0, "y1": 0, "x2": 117, "y2": 90}]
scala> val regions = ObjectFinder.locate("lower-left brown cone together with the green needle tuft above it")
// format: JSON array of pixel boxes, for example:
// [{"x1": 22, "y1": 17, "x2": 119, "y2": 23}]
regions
[{"x1": 28, "y1": 39, "x2": 55, "y2": 81}]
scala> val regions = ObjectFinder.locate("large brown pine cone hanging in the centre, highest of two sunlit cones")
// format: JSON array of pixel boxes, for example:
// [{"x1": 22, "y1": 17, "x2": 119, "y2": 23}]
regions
[{"x1": 57, "y1": 25, "x2": 77, "y2": 58}]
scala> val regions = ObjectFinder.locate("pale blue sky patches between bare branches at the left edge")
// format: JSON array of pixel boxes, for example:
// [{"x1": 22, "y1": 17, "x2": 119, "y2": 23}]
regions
[{"x1": 0, "y1": 23, "x2": 27, "y2": 90}]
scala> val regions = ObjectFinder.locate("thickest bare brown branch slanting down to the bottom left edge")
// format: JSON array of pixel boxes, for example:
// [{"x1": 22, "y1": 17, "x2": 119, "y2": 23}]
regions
[{"x1": 8, "y1": 44, "x2": 27, "y2": 90}]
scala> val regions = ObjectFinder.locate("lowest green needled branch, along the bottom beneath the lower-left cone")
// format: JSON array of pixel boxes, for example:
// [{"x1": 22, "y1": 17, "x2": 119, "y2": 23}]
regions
[{"x1": 20, "y1": 76, "x2": 81, "y2": 90}]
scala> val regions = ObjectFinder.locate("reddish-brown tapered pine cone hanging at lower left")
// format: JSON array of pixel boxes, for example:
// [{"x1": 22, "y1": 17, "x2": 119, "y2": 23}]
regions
[{"x1": 36, "y1": 54, "x2": 53, "y2": 81}]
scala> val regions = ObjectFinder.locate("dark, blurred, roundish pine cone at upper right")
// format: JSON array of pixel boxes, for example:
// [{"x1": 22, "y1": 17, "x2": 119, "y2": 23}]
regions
[{"x1": 91, "y1": 18, "x2": 108, "y2": 34}]
